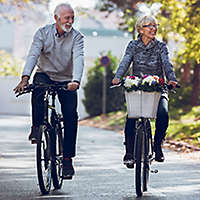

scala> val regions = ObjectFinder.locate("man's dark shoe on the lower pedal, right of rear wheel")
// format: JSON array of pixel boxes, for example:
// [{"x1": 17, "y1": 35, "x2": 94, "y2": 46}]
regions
[{"x1": 63, "y1": 158, "x2": 75, "y2": 179}]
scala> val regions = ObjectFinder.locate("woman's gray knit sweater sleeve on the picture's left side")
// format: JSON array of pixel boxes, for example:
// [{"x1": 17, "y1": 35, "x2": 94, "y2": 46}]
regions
[{"x1": 115, "y1": 41, "x2": 133, "y2": 78}]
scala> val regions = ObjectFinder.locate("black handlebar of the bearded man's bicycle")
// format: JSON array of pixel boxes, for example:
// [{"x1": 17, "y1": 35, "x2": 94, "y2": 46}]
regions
[{"x1": 16, "y1": 84, "x2": 67, "y2": 97}]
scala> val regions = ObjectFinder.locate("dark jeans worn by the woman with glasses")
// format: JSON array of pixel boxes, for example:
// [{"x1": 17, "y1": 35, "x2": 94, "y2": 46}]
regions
[{"x1": 125, "y1": 97, "x2": 169, "y2": 153}]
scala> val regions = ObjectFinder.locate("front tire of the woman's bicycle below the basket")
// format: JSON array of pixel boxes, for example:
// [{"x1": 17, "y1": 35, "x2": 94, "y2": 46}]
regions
[{"x1": 135, "y1": 122, "x2": 144, "y2": 197}]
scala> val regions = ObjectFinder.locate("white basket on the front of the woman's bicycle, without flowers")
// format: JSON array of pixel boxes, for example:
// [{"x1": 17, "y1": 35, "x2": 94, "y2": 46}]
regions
[{"x1": 125, "y1": 91, "x2": 161, "y2": 118}]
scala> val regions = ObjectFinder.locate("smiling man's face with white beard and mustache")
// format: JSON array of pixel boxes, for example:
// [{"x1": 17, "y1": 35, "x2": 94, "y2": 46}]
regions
[{"x1": 56, "y1": 8, "x2": 74, "y2": 32}]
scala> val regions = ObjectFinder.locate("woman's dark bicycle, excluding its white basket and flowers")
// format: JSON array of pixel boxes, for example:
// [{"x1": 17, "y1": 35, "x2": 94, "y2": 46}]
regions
[{"x1": 110, "y1": 82, "x2": 180, "y2": 197}]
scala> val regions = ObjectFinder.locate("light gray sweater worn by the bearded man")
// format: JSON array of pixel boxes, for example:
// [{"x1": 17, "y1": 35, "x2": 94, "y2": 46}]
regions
[{"x1": 22, "y1": 24, "x2": 84, "y2": 82}]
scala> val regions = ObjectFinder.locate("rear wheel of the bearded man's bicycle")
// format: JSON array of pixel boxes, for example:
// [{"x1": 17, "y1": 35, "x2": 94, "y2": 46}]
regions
[{"x1": 52, "y1": 123, "x2": 63, "y2": 189}]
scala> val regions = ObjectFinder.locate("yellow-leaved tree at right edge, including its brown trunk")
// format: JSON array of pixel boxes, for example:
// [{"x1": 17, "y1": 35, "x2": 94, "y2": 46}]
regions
[{"x1": 154, "y1": 0, "x2": 200, "y2": 106}]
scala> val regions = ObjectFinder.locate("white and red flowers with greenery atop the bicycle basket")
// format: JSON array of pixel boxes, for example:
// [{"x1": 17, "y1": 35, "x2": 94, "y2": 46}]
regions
[{"x1": 123, "y1": 75, "x2": 164, "y2": 92}]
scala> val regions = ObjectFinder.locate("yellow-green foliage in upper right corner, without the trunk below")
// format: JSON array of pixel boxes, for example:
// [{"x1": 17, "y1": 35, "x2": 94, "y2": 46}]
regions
[{"x1": 151, "y1": 0, "x2": 200, "y2": 64}]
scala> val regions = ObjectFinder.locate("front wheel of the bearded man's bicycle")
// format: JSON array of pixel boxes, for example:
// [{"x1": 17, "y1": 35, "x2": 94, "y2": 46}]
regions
[{"x1": 36, "y1": 125, "x2": 52, "y2": 194}]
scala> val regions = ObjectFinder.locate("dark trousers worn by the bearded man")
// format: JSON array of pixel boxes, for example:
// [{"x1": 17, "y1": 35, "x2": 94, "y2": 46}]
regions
[{"x1": 32, "y1": 73, "x2": 78, "y2": 157}]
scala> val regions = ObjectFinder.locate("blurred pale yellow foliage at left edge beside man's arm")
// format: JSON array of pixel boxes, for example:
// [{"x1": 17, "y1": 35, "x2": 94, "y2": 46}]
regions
[{"x1": 0, "y1": 50, "x2": 23, "y2": 76}]
